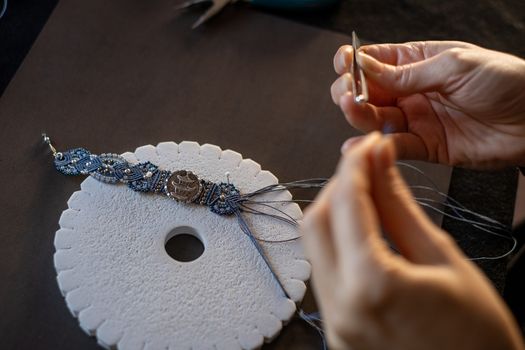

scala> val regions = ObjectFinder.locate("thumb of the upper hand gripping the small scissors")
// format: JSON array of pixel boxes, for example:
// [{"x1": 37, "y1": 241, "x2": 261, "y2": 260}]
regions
[{"x1": 357, "y1": 50, "x2": 457, "y2": 96}]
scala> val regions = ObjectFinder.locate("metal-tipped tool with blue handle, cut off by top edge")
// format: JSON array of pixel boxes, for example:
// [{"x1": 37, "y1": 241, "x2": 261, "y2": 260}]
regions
[{"x1": 176, "y1": 0, "x2": 339, "y2": 29}]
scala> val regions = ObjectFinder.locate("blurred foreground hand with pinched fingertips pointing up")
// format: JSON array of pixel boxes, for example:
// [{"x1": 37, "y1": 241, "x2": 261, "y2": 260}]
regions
[{"x1": 302, "y1": 133, "x2": 523, "y2": 350}]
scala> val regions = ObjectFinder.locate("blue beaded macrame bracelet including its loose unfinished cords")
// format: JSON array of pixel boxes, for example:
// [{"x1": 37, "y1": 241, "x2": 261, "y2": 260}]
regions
[{"x1": 42, "y1": 134, "x2": 327, "y2": 299}]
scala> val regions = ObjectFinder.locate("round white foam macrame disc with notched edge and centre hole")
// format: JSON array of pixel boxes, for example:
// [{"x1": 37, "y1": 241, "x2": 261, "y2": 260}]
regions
[{"x1": 54, "y1": 141, "x2": 310, "y2": 350}]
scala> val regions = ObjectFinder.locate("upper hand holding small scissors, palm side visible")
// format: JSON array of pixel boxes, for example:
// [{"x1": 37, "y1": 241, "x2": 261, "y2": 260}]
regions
[{"x1": 332, "y1": 41, "x2": 525, "y2": 169}]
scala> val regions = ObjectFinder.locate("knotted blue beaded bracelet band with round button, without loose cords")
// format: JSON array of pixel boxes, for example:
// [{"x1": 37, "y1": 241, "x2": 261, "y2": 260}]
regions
[{"x1": 44, "y1": 136, "x2": 241, "y2": 215}]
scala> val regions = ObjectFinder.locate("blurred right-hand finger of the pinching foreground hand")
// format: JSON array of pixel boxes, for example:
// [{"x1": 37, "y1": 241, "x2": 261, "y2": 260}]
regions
[{"x1": 372, "y1": 138, "x2": 458, "y2": 265}]
